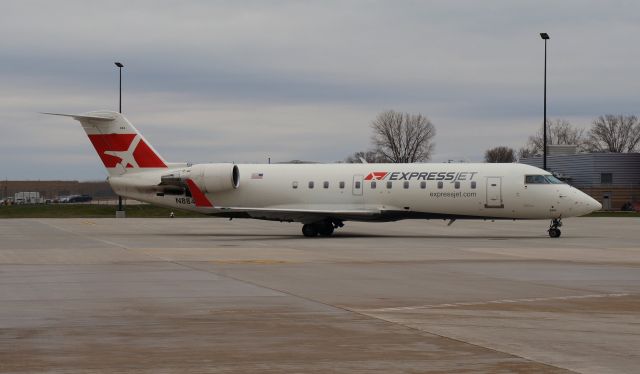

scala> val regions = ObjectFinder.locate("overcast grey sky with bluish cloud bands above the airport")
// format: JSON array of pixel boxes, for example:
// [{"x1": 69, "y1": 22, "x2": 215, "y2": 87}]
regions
[{"x1": 0, "y1": 0, "x2": 640, "y2": 180}]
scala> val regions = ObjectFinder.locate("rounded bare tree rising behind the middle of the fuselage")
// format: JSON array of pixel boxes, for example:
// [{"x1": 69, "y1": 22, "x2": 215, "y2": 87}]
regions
[{"x1": 371, "y1": 110, "x2": 436, "y2": 163}]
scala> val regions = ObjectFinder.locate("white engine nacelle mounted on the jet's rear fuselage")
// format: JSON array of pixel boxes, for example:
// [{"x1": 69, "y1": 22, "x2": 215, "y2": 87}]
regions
[{"x1": 189, "y1": 164, "x2": 240, "y2": 193}]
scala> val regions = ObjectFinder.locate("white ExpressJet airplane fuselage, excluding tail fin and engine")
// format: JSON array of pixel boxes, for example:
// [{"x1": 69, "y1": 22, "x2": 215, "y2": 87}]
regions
[{"x1": 110, "y1": 163, "x2": 600, "y2": 222}]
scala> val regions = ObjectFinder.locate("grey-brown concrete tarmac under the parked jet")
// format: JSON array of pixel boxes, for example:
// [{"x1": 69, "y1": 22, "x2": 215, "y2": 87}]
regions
[{"x1": 0, "y1": 218, "x2": 640, "y2": 373}]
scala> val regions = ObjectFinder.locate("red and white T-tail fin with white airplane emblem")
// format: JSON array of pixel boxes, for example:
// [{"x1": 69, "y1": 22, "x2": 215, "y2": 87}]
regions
[{"x1": 44, "y1": 111, "x2": 167, "y2": 176}]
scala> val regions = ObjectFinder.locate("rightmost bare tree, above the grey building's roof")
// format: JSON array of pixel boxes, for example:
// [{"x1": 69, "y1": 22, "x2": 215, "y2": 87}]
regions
[{"x1": 586, "y1": 114, "x2": 640, "y2": 153}]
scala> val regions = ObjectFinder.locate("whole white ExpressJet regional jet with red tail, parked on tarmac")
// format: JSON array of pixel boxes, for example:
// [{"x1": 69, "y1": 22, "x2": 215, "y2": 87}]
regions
[{"x1": 46, "y1": 111, "x2": 602, "y2": 238}]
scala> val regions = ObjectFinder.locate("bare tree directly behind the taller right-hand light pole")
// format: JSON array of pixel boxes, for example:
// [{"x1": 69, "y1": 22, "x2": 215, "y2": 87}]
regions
[{"x1": 518, "y1": 119, "x2": 586, "y2": 158}]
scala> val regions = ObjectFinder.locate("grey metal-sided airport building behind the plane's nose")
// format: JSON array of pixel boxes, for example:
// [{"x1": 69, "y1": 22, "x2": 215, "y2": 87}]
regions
[{"x1": 520, "y1": 151, "x2": 640, "y2": 210}]
